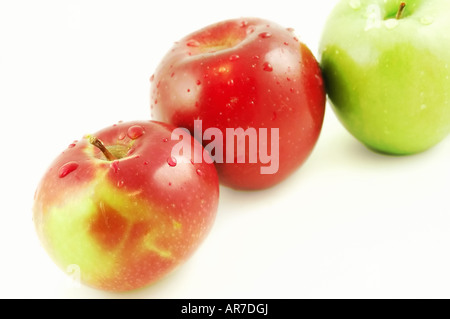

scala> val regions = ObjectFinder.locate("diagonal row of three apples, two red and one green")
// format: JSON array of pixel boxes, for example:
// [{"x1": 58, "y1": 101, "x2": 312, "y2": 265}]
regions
[{"x1": 33, "y1": 0, "x2": 450, "y2": 291}]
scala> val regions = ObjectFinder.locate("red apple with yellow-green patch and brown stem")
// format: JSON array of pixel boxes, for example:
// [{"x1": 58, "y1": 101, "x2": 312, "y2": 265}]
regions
[{"x1": 33, "y1": 121, "x2": 219, "y2": 291}]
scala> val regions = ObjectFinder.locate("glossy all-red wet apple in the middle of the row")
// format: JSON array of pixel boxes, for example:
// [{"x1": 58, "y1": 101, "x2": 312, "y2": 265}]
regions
[{"x1": 151, "y1": 18, "x2": 326, "y2": 190}]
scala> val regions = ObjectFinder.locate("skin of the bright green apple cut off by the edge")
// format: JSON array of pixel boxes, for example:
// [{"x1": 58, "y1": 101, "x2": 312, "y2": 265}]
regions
[{"x1": 319, "y1": 0, "x2": 450, "y2": 155}]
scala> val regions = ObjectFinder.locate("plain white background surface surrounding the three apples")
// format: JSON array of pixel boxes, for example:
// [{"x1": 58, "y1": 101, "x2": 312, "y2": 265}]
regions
[{"x1": 0, "y1": 0, "x2": 450, "y2": 298}]
